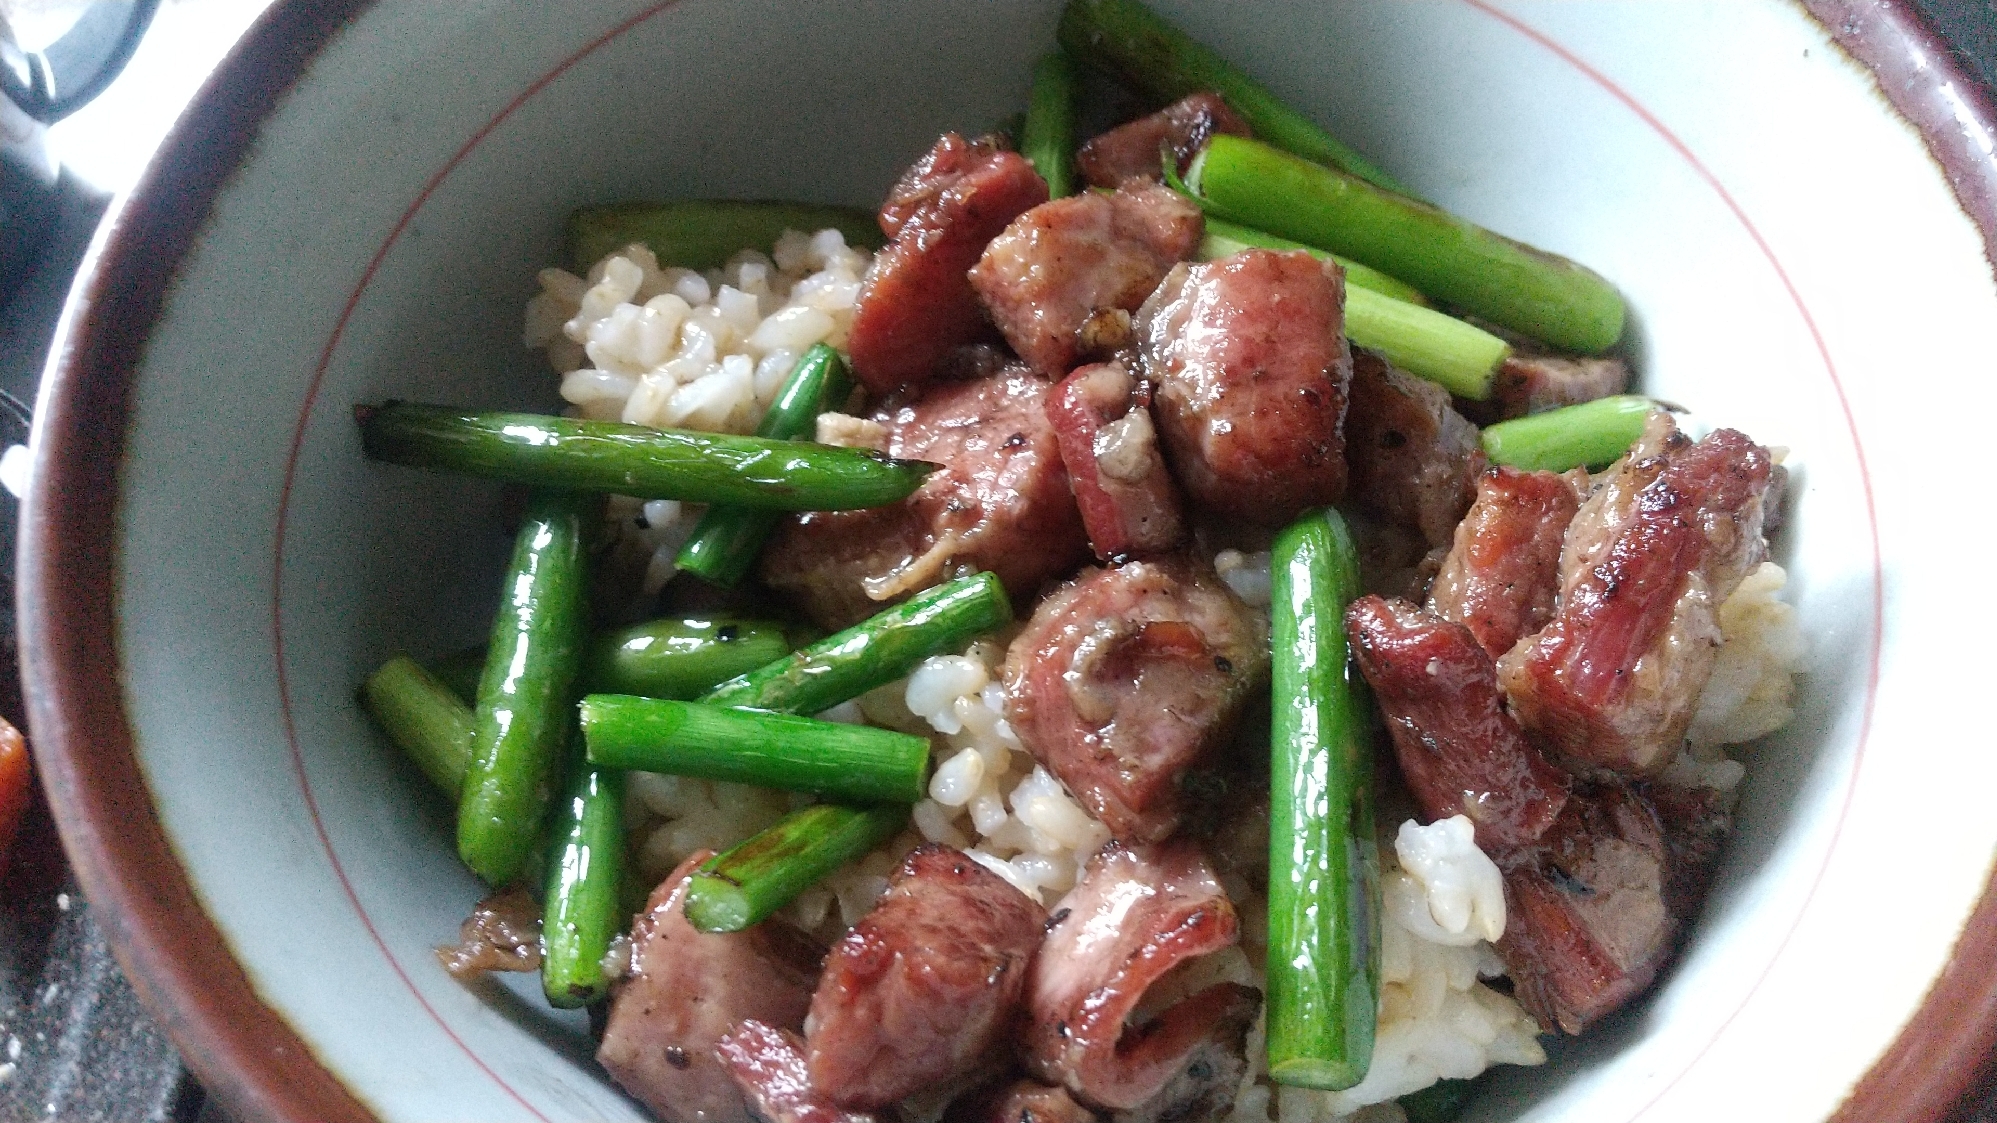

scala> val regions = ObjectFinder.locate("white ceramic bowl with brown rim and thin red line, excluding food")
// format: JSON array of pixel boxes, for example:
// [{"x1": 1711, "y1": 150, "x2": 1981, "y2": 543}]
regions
[{"x1": 22, "y1": 0, "x2": 1997, "y2": 1123}]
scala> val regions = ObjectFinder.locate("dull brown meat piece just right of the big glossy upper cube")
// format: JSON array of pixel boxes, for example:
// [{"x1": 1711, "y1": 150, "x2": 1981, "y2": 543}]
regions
[{"x1": 1346, "y1": 350, "x2": 1484, "y2": 546}]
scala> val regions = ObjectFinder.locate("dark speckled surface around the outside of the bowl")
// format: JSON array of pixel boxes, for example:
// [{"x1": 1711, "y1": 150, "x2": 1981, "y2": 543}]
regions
[{"x1": 0, "y1": 0, "x2": 1997, "y2": 1123}]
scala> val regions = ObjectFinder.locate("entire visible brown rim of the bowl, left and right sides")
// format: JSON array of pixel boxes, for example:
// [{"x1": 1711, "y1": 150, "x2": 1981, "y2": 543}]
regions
[{"x1": 20, "y1": 0, "x2": 1997, "y2": 1123}]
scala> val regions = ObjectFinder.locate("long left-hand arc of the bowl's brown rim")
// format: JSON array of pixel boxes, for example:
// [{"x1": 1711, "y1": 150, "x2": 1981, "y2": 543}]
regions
[{"x1": 20, "y1": 0, "x2": 375, "y2": 1123}]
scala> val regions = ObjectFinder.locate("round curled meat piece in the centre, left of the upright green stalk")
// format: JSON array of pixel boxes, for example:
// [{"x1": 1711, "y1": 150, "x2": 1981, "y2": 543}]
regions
[{"x1": 1004, "y1": 558, "x2": 1268, "y2": 841}]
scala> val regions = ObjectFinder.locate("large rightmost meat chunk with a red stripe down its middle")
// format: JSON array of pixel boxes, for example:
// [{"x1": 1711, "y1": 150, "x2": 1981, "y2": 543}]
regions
[{"x1": 1498, "y1": 410, "x2": 1769, "y2": 773}]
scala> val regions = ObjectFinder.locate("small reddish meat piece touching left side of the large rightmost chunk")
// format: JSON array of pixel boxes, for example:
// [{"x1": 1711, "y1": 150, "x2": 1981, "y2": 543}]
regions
[{"x1": 1428, "y1": 466, "x2": 1588, "y2": 659}]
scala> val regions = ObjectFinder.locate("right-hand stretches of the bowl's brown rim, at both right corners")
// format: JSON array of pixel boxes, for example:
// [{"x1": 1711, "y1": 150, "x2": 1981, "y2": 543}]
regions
[{"x1": 1803, "y1": 0, "x2": 1997, "y2": 1123}]
